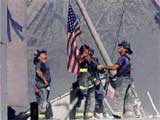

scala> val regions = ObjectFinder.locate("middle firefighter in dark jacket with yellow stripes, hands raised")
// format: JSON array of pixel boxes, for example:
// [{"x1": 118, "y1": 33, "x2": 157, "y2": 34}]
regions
[{"x1": 75, "y1": 45, "x2": 104, "y2": 119}]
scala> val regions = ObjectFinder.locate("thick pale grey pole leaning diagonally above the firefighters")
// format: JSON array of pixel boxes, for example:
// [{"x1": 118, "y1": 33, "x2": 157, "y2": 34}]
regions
[{"x1": 76, "y1": 0, "x2": 116, "y2": 75}]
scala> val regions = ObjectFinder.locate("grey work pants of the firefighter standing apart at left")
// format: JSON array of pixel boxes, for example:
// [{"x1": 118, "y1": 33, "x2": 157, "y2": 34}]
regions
[{"x1": 35, "y1": 88, "x2": 53, "y2": 119}]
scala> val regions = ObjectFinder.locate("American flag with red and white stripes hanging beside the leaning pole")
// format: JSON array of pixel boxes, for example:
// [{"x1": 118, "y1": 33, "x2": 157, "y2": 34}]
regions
[{"x1": 67, "y1": 3, "x2": 81, "y2": 74}]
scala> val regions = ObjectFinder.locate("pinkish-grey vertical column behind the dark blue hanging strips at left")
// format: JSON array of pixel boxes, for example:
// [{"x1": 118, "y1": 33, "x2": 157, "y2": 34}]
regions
[{"x1": 7, "y1": 0, "x2": 29, "y2": 112}]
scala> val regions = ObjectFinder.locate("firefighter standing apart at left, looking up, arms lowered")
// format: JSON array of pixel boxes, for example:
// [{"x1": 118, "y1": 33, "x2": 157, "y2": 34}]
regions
[{"x1": 33, "y1": 50, "x2": 53, "y2": 119}]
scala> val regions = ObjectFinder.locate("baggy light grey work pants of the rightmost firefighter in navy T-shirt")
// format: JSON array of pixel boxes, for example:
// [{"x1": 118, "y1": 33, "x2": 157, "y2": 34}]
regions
[{"x1": 112, "y1": 77, "x2": 135, "y2": 117}]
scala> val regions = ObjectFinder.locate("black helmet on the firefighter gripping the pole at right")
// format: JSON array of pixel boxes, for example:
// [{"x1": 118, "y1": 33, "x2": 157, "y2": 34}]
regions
[{"x1": 118, "y1": 40, "x2": 133, "y2": 54}]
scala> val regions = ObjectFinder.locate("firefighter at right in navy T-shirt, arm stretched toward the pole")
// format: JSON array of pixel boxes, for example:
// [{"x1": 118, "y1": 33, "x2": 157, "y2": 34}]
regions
[{"x1": 99, "y1": 40, "x2": 134, "y2": 117}]
